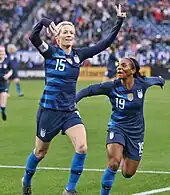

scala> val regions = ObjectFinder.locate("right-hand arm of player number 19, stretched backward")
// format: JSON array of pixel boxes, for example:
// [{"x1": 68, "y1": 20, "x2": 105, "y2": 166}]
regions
[{"x1": 144, "y1": 76, "x2": 165, "y2": 87}]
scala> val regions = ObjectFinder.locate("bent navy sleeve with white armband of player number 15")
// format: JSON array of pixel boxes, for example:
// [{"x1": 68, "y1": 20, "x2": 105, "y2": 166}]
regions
[{"x1": 30, "y1": 18, "x2": 52, "y2": 56}]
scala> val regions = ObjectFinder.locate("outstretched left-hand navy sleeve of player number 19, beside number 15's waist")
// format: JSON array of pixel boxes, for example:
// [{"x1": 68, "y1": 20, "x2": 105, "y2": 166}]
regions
[{"x1": 76, "y1": 82, "x2": 113, "y2": 102}]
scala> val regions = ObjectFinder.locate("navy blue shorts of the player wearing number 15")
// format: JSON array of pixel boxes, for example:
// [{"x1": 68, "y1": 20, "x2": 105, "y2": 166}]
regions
[{"x1": 37, "y1": 107, "x2": 83, "y2": 142}]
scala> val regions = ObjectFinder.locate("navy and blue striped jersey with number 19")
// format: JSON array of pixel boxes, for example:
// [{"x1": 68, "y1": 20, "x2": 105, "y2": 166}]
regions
[{"x1": 76, "y1": 77, "x2": 164, "y2": 139}]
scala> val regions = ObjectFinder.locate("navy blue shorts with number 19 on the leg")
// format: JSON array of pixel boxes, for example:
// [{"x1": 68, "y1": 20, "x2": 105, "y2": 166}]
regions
[{"x1": 106, "y1": 129, "x2": 144, "y2": 161}]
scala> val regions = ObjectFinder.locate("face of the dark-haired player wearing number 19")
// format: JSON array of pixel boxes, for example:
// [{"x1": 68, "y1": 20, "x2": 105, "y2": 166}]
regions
[{"x1": 117, "y1": 58, "x2": 135, "y2": 79}]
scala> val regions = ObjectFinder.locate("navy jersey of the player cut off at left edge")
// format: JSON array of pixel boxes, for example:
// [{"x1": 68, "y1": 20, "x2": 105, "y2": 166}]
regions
[{"x1": 0, "y1": 58, "x2": 11, "y2": 82}]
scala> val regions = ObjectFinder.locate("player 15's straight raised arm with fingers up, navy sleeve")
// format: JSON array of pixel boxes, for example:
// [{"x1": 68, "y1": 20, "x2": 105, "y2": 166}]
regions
[{"x1": 78, "y1": 5, "x2": 126, "y2": 62}]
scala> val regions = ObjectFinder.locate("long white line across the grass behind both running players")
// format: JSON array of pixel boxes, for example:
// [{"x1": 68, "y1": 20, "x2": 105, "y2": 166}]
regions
[{"x1": 0, "y1": 165, "x2": 170, "y2": 175}]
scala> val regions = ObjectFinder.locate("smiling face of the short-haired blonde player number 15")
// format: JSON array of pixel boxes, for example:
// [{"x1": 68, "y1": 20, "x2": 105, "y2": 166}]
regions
[{"x1": 57, "y1": 25, "x2": 75, "y2": 47}]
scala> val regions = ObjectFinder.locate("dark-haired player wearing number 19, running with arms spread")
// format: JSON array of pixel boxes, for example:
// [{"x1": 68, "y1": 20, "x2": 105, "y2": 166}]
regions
[{"x1": 76, "y1": 57, "x2": 165, "y2": 195}]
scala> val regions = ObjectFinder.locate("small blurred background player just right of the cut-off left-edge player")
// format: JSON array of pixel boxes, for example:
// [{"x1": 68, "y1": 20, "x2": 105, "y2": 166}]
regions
[{"x1": 7, "y1": 44, "x2": 24, "y2": 97}]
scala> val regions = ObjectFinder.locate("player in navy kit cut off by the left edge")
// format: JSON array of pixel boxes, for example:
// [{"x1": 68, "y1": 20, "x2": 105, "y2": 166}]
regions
[{"x1": 0, "y1": 46, "x2": 12, "y2": 121}]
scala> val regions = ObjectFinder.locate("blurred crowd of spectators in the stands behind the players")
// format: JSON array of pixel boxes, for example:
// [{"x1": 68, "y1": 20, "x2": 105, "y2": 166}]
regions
[{"x1": 0, "y1": 0, "x2": 170, "y2": 66}]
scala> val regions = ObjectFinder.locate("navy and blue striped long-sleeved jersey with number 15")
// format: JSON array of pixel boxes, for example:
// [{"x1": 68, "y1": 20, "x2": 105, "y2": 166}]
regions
[{"x1": 30, "y1": 18, "x2": 123, "y2": 111}]
